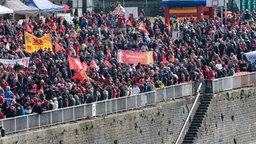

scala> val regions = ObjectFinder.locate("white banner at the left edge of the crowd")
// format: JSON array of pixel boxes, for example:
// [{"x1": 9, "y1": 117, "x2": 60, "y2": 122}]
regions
[{"x1": 0, "y1": 57, "x2": 29, "y2": 67}]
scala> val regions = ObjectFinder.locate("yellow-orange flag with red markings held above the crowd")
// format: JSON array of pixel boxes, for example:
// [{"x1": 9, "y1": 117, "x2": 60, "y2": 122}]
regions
[{"x1": 24, "y1": 32, "x2": 52, "y2": 53}]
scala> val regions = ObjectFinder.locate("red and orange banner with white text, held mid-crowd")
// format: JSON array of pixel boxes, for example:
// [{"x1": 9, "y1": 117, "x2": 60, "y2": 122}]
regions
[{"x1": 117, "y1": 50, "x2": 154, "y2": 64}]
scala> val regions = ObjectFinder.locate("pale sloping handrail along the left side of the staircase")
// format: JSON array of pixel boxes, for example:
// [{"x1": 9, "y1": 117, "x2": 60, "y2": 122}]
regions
[{"x1": 175, "y1": 83, "x2": 202, "y2": 144}]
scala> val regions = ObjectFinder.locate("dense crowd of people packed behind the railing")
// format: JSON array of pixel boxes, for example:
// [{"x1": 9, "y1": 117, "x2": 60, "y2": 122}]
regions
[{"x1": 0, "y1": 9, "x2": 256, "y2": 118}]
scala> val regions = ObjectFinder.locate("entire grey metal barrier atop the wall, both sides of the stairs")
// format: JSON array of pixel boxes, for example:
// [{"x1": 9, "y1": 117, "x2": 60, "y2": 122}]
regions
[{"x1": 0, "y1": 73, "x2": 256, "y2": 134}]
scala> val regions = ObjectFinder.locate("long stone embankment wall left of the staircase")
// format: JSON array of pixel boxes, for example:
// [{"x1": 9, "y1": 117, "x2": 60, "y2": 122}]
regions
[{"x1": 0, "y1": 97, "x2": 193, "y2": 144}]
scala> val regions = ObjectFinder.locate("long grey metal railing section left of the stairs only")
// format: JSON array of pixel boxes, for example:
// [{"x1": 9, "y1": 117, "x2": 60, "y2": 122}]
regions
[{"x1": 0, "y1": 82, "x2": 195, "y2": 134}]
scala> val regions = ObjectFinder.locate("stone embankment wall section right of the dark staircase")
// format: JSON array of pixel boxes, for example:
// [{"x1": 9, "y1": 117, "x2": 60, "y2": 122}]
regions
[{"x1": 196, "y1": 88, "x2": 256, "y2": 144}]
